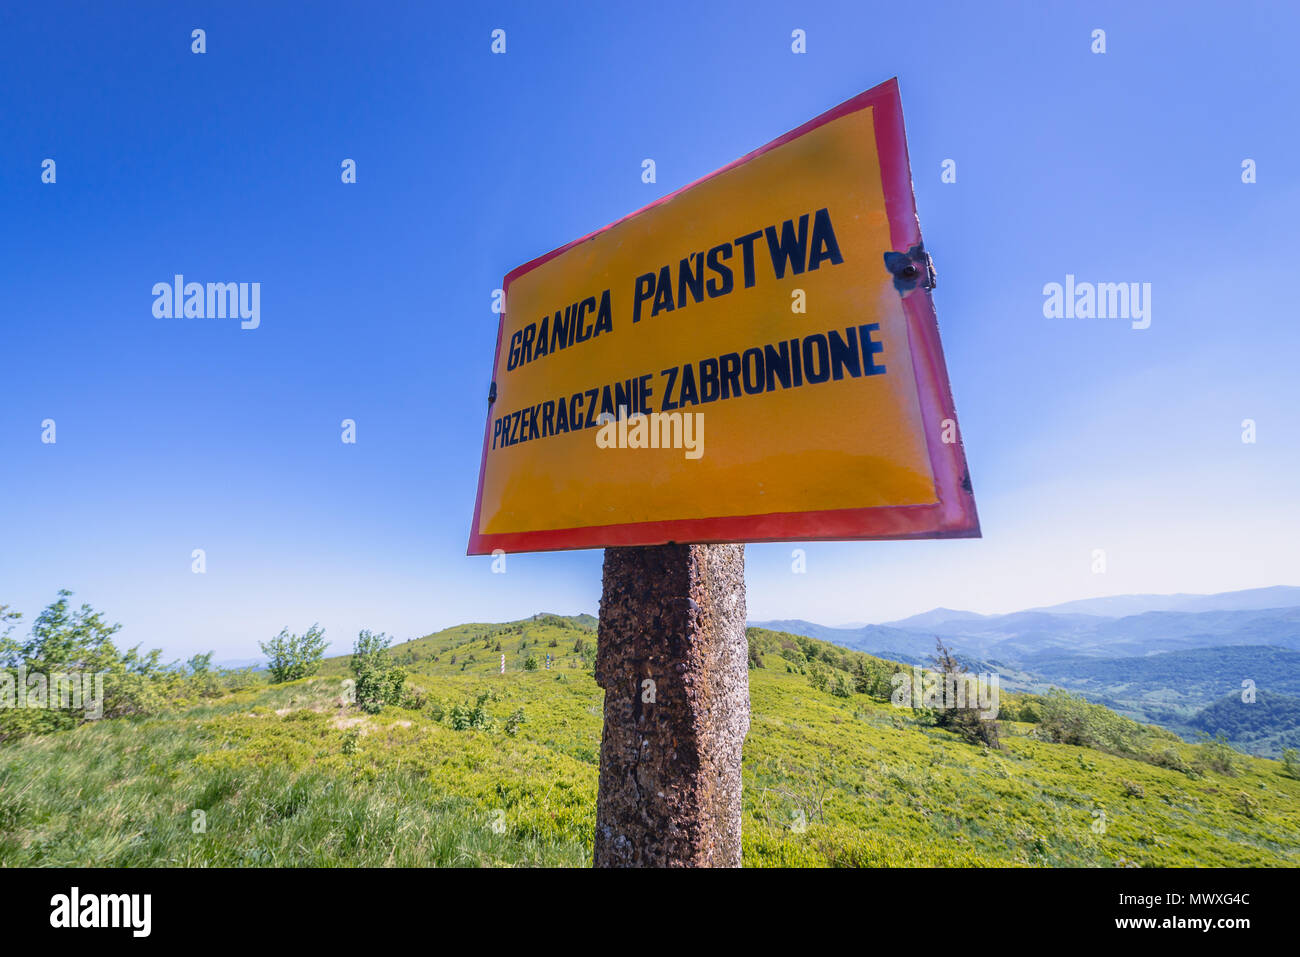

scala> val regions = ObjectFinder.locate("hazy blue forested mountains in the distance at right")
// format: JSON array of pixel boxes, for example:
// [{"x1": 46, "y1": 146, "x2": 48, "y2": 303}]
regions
[{"x1": 751, "y1": 585, "x2": 1300, "y2": 753}]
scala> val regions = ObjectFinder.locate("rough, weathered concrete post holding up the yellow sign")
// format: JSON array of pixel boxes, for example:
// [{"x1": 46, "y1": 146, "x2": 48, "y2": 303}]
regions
[{"x1": 594, "y1": 545, "x2": 749, "y2": 867}]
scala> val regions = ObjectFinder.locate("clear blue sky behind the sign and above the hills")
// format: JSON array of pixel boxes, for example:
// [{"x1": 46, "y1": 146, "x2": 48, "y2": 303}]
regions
[{"x1": 0, "y1": 3, "x2": 1300, "y2": 659}]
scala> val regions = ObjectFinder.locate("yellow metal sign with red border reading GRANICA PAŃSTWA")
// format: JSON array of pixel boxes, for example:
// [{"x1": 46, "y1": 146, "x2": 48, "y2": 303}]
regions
[{"x1": 471, "y1": 83, "x2": 974, "y2": 553}]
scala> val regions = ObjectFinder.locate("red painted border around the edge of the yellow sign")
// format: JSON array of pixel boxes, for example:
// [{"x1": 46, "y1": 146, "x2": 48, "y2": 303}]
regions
[{"x1": 467, "y1": 77, "x2": 980, "y2": 555}]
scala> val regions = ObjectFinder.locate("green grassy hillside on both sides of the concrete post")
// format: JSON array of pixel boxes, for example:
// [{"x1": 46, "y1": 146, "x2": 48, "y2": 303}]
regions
[{"x1": 0, "y1": 616, "x2": 1300, "y2": 866}]
